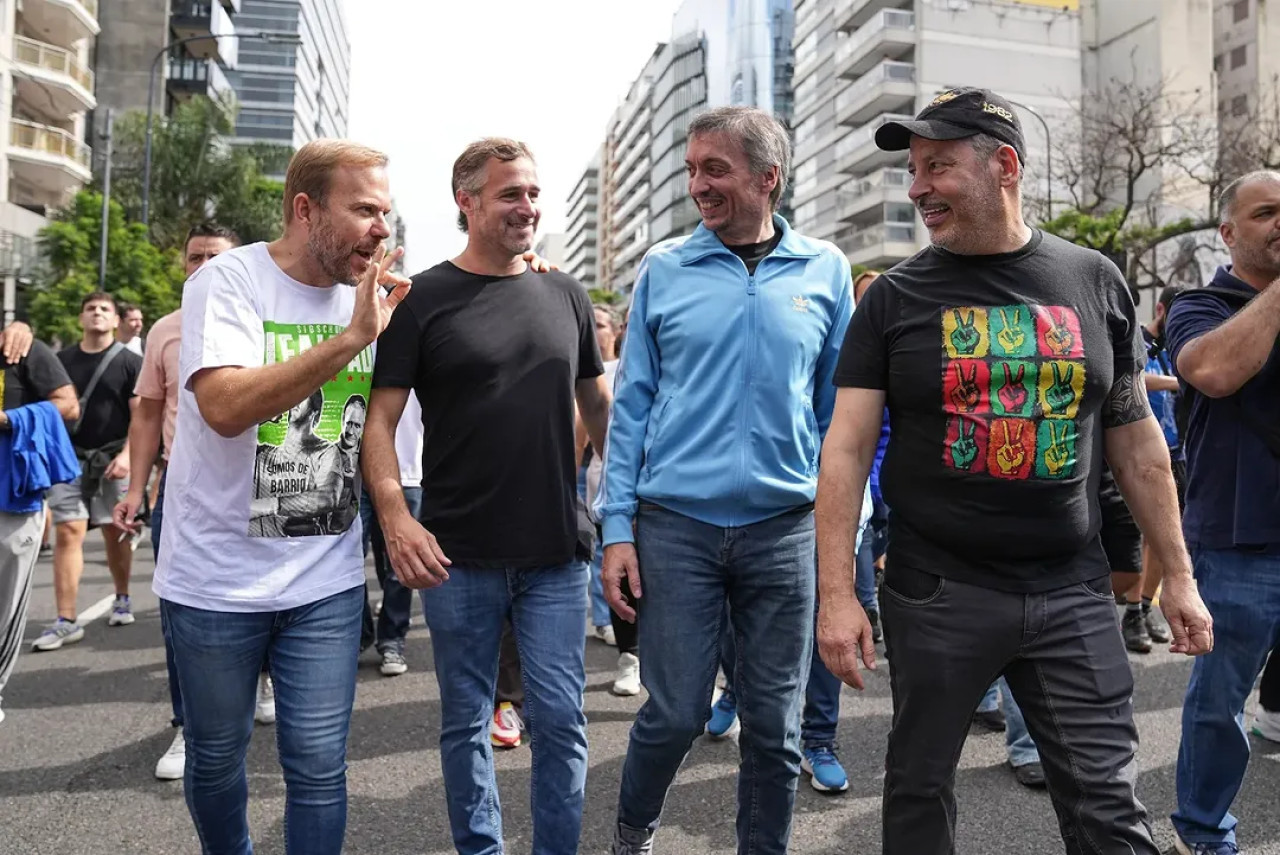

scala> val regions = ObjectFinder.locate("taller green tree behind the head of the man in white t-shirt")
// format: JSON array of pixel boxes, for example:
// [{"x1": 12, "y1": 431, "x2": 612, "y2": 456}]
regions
[{"x1": 104, "y1": 97, "x2": 289, "y2": 250}]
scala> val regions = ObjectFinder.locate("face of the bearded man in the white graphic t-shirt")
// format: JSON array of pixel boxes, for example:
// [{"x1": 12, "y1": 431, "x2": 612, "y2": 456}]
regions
[{"x1": 307, "y1": 166, "x2": 392, "y2": 285}]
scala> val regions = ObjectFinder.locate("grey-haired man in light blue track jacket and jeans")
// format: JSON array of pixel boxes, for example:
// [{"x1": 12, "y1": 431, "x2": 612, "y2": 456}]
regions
[{"x1": 596, "y1": 108, "x2": 854, "y2": 855}]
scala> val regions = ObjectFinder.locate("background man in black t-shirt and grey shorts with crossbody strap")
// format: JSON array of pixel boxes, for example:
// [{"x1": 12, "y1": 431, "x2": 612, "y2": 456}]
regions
[{"x1": 33, "y1": 292, "x2": 146, "y2": 650}]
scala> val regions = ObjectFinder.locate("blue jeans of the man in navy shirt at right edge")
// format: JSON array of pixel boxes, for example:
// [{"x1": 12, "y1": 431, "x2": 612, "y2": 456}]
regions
[{"x1": 1172, "y1": 549, "x2": 1280, "y2": 845}]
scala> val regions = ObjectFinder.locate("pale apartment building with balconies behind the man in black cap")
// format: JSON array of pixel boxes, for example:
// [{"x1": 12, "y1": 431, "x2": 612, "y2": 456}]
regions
[{"x1": 792, "y1": 0, "x2": 1082, "y2": 268}]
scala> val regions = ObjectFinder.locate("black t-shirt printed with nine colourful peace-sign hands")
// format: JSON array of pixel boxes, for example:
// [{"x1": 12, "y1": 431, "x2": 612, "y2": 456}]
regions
[{"x1": 836, "y1": 232, "x2": 1146, "y2": 591}]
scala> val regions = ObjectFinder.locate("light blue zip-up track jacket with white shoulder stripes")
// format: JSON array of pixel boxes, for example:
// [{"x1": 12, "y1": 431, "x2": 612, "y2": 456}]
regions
[{"x1": 596, "y1": 216, "x2": 854, "y2": 545}]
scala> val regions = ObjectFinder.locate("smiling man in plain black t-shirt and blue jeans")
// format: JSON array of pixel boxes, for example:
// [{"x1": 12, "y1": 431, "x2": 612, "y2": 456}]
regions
[{"x1": 361, "y1": 140, "x2": 609, "y2": 854}]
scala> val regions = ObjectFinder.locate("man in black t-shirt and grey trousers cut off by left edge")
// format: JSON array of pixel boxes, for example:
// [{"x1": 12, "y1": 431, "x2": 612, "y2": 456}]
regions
[{"x1": 0, "y1": 330, "x2": 79, "y2": 722}]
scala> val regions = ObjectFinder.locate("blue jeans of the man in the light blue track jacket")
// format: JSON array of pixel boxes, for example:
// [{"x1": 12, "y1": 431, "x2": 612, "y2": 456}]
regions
[{"x1": 618, "y1": 504, "x2": 814, "y2": 855}]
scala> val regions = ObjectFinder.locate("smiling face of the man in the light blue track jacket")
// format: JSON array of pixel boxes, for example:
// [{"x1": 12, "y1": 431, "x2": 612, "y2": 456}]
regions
[{"x1": 685, "y1": 133, "x2": 778, "y2": 246}]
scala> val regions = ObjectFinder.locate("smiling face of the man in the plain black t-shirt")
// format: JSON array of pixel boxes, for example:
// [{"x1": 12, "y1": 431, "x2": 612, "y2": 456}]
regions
[{"x1": 457, "y1": 157, "x2": 543, "y2": 257}]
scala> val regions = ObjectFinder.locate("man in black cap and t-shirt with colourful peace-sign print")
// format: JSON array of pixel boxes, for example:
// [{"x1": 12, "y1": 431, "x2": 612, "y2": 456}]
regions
[{"x1": 818, "y1": 88, "x2": 1212, "y2": 855}]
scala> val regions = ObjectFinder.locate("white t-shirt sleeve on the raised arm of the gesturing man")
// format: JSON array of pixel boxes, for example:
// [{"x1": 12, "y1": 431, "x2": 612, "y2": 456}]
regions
[{"x1": 178, "y1": 253, "x2": 266, "y2": 389}]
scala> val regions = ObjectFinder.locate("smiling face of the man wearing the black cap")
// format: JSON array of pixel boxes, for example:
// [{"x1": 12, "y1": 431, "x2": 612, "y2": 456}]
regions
[{"x1": 908, "y1": 137, "x2": 1012, "y2": 255}]
